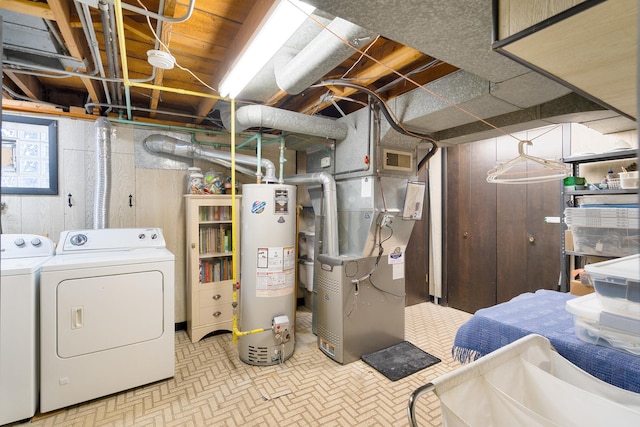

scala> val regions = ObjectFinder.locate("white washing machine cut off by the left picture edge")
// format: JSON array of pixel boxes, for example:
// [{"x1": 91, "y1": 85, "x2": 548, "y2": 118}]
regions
[{"x1": 0, "y1": 234, "x2": 55, "y2": 425}]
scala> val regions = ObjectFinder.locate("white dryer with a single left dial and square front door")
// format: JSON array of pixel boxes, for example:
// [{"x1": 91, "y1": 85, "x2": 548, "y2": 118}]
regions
[{"x1": 40, "y1": 228, "x2": 175, "y2": 412}]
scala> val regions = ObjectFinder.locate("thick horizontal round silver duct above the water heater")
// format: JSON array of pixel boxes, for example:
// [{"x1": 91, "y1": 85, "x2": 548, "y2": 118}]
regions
[{"x1": 219, "y1": 104, "x2": 349, "y2": 141}]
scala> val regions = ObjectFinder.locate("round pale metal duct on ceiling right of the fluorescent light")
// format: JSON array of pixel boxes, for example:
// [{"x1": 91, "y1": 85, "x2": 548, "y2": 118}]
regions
[{"x1": 275, "y1": 18, "x2": 373, "y2": 95}]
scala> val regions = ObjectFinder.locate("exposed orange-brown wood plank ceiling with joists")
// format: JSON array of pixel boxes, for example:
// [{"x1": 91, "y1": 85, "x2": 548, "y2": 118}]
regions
[{"x1": 0, "y1": 0, "x2": 456, "y2": 127}]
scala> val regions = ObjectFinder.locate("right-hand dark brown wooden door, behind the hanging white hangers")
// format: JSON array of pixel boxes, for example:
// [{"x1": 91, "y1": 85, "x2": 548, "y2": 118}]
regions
[{"x1": 497, "y1": 127, "x2": 562, "y2": 303}]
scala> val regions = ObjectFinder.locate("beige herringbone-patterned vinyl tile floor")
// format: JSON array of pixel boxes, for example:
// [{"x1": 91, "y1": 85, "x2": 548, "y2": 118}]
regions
[{"x1": 18, "y1": 302, "x2": 471, "y2": 427}]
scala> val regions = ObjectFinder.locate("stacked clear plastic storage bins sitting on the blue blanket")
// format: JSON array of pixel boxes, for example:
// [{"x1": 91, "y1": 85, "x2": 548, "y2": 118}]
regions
[{"x1": 566, "y1": 254, "x2": 640, "y2": 355}]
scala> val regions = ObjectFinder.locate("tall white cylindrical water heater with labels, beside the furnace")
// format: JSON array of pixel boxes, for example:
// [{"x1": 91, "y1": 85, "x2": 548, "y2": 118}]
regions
[{"x1": 238, "y1": 184, "x2": 297, "y2": 365}]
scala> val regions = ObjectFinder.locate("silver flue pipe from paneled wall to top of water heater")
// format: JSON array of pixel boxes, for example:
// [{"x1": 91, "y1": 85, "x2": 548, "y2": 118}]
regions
[{"x1": 144, "y1": 135, "x2": 277, "y2": 183}]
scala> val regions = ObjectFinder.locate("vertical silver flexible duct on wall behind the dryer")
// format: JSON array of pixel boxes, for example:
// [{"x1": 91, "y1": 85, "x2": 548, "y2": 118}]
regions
[{"x1": 93, "y1": 117, "x2": 111, "y2": 229}]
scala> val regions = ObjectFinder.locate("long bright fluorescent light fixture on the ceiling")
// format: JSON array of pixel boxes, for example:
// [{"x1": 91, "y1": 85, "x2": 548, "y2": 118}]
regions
[{"x1": 219, "y1": 0, "x2": 315, "y2": 98}]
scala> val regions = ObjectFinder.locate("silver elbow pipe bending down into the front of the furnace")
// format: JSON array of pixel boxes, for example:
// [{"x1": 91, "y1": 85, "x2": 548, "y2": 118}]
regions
[{"x1": 284, "y1": 172, "x2": 340, "y2": 257}]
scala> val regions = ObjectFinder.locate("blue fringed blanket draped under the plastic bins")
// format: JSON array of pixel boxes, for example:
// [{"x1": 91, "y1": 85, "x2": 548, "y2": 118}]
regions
[{"x1": 452, "y1": 290, "x2": 640, "y2": 393}]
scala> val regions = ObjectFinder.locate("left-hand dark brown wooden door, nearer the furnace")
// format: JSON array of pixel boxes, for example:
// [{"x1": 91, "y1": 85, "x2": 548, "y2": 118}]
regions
[{"x1": 445, "y1": 139, "x2": 497, "y2": 313}]
